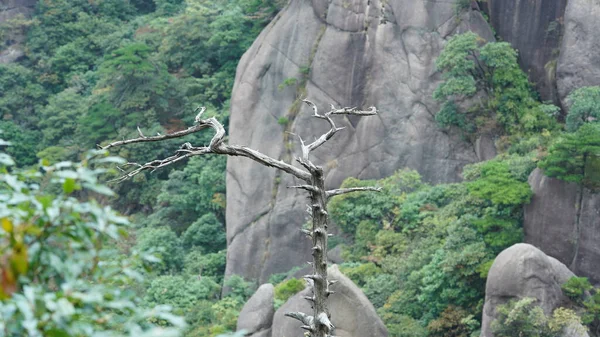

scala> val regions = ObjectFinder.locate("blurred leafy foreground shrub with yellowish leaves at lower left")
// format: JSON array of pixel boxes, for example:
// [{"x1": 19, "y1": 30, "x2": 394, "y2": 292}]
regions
[{"x1": 0, "y1": 153, "x2": 185, "y2": 337}]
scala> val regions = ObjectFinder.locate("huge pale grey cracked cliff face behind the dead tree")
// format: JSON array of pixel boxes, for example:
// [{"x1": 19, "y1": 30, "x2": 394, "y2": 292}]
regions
[{"x1": 226, "y1": 0, "x2": 493, "y2": 282}]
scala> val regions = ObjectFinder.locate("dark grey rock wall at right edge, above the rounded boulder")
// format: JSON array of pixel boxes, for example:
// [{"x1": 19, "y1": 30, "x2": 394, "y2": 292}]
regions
[{"x1": 524, "y1": 169, "x2": 600, "y2": 284}]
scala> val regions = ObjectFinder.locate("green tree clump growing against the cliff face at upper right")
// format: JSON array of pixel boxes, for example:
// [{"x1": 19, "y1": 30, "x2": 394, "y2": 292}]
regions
[{"x1": 433, "y1": 33, "x2": 558, "y2": 134}]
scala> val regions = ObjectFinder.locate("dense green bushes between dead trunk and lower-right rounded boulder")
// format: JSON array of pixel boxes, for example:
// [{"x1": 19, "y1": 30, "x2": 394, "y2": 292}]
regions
[{"x1": 330, "y1": 162, "x2": 534, "y2": 336}]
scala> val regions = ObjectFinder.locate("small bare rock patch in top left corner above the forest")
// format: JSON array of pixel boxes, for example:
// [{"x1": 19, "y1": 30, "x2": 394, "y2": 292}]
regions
[{"x1": 0, "y1": 0, "x2": 37, "y2": 64}]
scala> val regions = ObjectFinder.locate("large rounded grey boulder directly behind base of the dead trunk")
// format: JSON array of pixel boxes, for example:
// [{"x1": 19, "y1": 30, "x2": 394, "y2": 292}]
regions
[{"x1": 272, "y1": 265, "x2": 388, "y2": 337}]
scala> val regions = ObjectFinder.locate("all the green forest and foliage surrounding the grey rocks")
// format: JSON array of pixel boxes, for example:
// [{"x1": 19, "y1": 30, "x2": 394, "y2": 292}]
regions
[{"x1": 0, "y1": 0, "x2": 600, "y2": 337}]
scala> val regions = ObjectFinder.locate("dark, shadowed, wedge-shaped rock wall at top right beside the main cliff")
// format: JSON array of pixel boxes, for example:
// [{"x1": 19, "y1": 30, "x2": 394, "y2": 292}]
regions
[{"x1": 487, "y1": 0, "x2": 564, "y2": 102}]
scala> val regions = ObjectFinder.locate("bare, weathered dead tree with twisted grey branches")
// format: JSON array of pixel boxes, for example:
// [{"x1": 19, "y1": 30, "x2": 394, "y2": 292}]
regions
[{"x1": 99, "y1": 100, "x2": 380, "y2": 337}]
